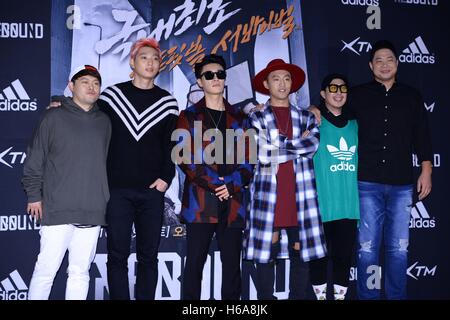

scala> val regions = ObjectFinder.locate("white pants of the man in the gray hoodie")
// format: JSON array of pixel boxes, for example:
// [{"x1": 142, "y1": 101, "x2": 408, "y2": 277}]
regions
[{"x1": 28, "y1": 224, "x2": 100, "y2": 300}]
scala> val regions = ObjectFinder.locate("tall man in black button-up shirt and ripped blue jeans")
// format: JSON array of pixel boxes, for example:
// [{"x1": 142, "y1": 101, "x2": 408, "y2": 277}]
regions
[{"x1": 347, "y1": 40, "x2": 432, "y2": 299}]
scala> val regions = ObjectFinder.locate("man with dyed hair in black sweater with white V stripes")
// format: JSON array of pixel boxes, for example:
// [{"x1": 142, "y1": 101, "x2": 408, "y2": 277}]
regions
[{"x1": 99, "y1": 38, "x2": 178, "y2": 300}]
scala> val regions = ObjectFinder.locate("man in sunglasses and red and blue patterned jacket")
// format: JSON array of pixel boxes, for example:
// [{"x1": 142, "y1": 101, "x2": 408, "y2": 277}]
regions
[{"x1": 177, "y1": 54, "x2": 252, "y2": 300}]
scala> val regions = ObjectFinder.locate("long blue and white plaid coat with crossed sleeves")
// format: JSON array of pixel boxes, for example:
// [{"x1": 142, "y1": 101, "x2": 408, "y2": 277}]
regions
[{"x1": 243, "y1": 102, "x2": 326, "y2": 263}]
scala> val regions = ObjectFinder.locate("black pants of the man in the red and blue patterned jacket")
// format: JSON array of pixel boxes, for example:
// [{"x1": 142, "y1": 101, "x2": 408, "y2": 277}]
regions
[{"x1": 183, "y1": 205, "x2": 242, "y2": 300}]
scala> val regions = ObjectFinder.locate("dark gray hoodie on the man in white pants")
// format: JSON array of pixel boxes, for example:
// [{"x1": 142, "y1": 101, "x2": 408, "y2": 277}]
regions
[{"x1": 22, "y1": 98, "x2": 111, "y2": 225}]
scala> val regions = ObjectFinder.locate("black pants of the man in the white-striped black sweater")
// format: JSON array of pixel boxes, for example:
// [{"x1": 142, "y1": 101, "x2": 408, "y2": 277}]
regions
[{"x1": 106, "y1": 188, "x2": 164, "y2": 300}]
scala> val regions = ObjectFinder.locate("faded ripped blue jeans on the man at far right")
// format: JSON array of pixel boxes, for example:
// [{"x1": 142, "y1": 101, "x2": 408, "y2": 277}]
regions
[{"x1": 357, "y1": 181, "x2": 413, "y2": 300}]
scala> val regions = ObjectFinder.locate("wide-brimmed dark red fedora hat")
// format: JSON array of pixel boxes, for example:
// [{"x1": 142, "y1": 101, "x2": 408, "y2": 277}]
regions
[{"x1": 253, "y1": 59, "x2": 306, "y2": 95}]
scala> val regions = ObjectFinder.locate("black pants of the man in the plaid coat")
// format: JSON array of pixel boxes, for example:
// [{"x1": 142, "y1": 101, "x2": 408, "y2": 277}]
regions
[{"x1": 256, "y1": 227, "x2": 308, "y2": 300}]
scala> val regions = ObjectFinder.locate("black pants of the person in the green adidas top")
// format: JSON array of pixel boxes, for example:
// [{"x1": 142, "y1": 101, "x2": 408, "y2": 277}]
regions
[{"x1": 309, "y1": 219, "x2": 357, "y2": 287}]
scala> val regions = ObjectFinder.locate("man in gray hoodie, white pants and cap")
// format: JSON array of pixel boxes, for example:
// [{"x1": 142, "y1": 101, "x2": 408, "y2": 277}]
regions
[{"x1": 22, "y1": 65, "x2": 111, "y2": 300}]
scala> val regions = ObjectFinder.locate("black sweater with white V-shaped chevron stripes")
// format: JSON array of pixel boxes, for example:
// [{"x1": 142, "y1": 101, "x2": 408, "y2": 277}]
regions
[{"x1": 98, "y1": 81, "x2": 178, "y2": 188}]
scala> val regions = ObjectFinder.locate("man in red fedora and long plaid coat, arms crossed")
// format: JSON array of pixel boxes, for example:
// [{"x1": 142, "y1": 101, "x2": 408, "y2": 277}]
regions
[{"x1": 244, "y1": 59, "x2": 326, "y2": 300}]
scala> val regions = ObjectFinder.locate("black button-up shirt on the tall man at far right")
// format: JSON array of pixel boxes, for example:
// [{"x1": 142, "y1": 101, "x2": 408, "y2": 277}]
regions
[{"x1": 345, "y1": 81, "x2": 432, "y2": 185}]
